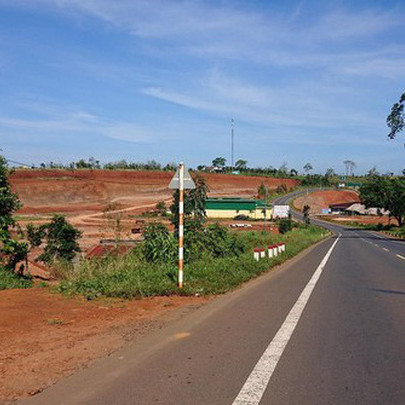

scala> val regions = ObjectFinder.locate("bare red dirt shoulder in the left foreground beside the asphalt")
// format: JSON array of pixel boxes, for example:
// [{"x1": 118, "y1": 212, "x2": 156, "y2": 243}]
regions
[{"x1": 0, "y1": 288, "x2": 208, "y2": 403}]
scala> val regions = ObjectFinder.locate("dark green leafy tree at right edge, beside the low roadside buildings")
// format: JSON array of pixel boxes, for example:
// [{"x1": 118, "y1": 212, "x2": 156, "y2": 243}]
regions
[{"x1": 360, "y1": 175, "x2": 405, "y2": 226}]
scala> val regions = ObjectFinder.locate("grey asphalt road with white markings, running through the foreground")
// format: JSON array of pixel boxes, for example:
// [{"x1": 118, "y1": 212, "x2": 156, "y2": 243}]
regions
[{"x1": 23, "y1": 191, "x2": 405, "y2": 405}]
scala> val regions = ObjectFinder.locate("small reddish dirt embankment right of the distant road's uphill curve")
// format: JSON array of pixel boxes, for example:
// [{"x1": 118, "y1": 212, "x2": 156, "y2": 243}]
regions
[{"x1": 294, "y1": 190, "x2": 360, "y2": 214}]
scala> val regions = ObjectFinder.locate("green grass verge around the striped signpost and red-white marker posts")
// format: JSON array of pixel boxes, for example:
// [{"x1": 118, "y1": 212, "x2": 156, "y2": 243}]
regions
[{"x1": 59, "y1": 226, "x2": 329, "y2": 299}]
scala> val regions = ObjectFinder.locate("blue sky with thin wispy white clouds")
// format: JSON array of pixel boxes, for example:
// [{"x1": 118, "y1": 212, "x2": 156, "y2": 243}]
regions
[{"x1": 0, "y1": 0, "x2": 405, "y2": 172}]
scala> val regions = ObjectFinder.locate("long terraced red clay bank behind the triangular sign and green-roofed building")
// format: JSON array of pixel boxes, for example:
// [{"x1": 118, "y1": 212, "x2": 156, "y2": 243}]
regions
[{"x1": 10, "y1": 169, "x2": 297, "y2": 213}]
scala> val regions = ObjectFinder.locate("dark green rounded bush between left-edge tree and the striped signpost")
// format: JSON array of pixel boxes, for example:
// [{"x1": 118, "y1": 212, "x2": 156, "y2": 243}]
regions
[{"x1": 37, "y1": 215, "x2": 81, "y2": 264}]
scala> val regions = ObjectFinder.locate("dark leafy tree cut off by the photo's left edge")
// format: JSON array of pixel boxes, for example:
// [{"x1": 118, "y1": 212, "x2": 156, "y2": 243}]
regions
[{"x1": 0, "y1": 155, "x2": 28, "y2": 274}]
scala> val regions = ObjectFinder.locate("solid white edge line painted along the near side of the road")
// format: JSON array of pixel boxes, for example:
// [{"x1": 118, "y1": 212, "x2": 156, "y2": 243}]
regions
[{"x1": 232, "y1": 233, "x2": 342, "y2": 405}]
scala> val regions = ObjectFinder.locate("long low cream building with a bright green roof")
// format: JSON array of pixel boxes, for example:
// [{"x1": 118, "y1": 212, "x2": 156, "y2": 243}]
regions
[{"x1": 205, "y1": 197, "x2": 273, "y2": 219}]
